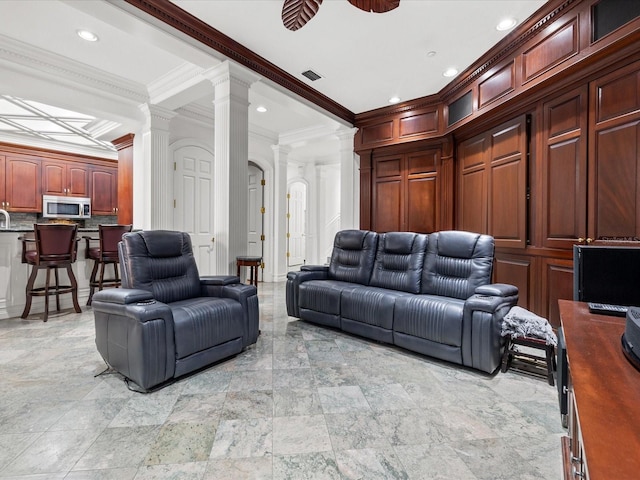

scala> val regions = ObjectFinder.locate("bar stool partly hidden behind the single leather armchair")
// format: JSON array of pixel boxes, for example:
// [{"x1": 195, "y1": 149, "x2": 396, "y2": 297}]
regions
[{"x1": 82, "y1": 225, "x2": 131, "y2": 305}]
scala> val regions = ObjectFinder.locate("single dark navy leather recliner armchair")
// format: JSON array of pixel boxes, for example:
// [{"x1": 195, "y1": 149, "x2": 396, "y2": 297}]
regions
[{"x1": 92, "y1": 230, "x2": 258, "y2": 390}]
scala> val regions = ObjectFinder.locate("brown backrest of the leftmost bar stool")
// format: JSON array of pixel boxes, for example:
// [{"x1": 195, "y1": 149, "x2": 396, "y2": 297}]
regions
[{"x1": 33, "y1": 223, "x2": 78, "y2": 265}]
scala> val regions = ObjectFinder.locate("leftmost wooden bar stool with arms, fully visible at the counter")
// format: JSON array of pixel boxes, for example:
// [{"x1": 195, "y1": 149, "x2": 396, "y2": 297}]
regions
[{"x1": 21, "y1": 223, "x2": 82, "y2": 322}]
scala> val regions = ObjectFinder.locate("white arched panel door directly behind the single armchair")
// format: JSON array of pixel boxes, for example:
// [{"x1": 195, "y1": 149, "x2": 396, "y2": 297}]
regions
[{"x1": 173, "y1": 146, "x2": 216, "y2": 275}]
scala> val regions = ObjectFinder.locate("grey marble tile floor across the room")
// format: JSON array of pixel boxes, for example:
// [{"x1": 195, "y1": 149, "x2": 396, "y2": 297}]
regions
[{"x1": 0, "y1": 283, "x2": 564, "y2": 480}]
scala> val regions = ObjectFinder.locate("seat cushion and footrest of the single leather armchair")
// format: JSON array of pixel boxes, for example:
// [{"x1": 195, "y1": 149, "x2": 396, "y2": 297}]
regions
[{"x1": 169, "y1": 297, "x2": 244, "y2": 358}]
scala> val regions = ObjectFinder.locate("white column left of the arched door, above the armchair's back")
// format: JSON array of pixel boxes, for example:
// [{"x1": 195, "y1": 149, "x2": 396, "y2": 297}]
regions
[{"x1": 138, "y1": 104, "x2": 176, "y2": 230}]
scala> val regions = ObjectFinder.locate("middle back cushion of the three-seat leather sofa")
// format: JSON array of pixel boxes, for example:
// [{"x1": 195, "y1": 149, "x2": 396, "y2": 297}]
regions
[{"x1": 370, "y1": 232, "x2": 428, "y2": 293}]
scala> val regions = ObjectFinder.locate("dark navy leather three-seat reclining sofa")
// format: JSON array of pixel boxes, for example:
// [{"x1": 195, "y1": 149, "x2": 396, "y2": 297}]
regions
[{"x1": 286, "y1": 230, "x2": 518, "y2": 372}]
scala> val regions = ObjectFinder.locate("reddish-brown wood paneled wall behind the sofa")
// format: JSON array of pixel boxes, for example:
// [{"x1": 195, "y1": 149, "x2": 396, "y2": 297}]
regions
[{"x1": 355, "y1": 0, "x2": 640, "y2": 326}]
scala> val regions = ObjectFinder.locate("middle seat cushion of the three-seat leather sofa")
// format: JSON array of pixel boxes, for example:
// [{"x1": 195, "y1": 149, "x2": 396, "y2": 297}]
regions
[{"x1": 340, "y1": 287, "x2": 411, "y2": 330}]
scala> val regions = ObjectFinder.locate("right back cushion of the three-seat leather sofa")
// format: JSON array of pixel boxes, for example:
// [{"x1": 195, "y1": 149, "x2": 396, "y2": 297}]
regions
[{"x1": 421, "y1": 230, "x2": 494, "y2": 300}]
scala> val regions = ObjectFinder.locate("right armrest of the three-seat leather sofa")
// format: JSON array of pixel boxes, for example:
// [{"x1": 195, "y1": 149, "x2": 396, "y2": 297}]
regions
[{"x1": 462, "y1": 283, "x2": 518, "y2": 373}]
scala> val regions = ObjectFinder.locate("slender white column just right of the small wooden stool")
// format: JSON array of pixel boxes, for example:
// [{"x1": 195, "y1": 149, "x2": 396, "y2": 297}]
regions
[{"x1": 271, "y1": 145, "x2": 291, "y2": 282}]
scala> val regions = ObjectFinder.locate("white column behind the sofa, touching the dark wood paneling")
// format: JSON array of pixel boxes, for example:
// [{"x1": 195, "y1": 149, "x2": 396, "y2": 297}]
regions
[{"x1": 336, "y1": 128, "x2": 360, "y2": 230}]
